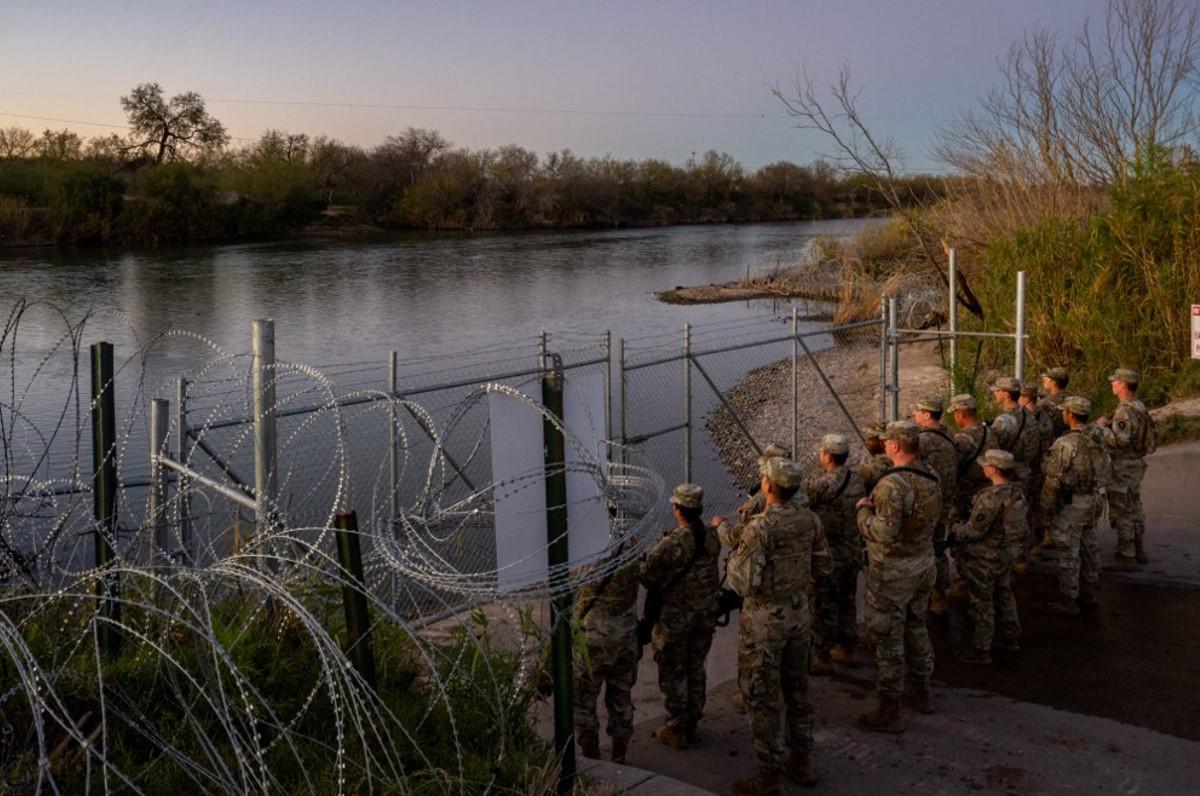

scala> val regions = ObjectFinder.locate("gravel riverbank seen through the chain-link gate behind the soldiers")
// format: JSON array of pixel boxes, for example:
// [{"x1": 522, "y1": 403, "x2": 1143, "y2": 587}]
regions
[{"x1": 706, "y1": 341, "x2": 947, "y2": 484}]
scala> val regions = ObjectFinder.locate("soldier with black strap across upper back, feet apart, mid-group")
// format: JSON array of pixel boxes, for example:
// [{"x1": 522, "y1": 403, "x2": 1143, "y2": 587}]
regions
[{"x1": 857, "y1": 421, "x2": 942, "y2": 732}]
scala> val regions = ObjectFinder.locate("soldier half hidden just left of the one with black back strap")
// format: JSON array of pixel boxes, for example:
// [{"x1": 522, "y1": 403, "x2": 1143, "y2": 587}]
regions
[{"x1": 803, "y1": 433, "x2": 866, "y2": 668}]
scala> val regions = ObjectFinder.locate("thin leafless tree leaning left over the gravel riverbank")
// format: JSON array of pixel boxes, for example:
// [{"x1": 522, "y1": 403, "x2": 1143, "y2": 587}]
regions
[{"x1": 772, "y1": 65, "x2": 983, "y2": 318}]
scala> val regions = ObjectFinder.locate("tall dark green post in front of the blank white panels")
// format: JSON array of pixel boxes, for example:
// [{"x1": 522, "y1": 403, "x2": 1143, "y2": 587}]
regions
[{"x1": 541, "y1": 354, "x2": 575, "y2": 796}]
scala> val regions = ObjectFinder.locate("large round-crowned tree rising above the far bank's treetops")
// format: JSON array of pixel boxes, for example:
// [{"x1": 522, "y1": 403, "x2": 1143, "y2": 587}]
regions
[{"x1": 121, "y1": 83, "x2": 229, "y2": 163}]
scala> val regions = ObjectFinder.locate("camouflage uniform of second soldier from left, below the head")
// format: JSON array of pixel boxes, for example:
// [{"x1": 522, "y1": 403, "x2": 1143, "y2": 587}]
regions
[{"x1": 641, "y1": 525, "x2": 721, "y2": 731}]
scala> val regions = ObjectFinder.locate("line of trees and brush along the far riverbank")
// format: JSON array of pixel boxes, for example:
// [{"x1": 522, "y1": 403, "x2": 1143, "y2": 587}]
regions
[{"x1": 0, "y1": 84, "x2": 944, "y2": 244}]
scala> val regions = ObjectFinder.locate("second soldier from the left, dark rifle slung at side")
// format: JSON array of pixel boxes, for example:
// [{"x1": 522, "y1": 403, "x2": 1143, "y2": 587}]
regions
[{"x1": 641, "y1": 484, "x2": 721, "y2": 749}]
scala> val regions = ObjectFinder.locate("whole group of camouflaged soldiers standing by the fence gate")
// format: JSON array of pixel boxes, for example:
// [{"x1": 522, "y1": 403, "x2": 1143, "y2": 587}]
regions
[{"x1": 575, "y1": 367, "x2": 1154, "y2": 794}]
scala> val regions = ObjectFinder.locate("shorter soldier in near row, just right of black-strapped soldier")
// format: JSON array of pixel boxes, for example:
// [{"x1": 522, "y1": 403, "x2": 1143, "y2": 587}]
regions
[{"x1": 953, "y1": 450, "x2": 1027, "y2": 664}]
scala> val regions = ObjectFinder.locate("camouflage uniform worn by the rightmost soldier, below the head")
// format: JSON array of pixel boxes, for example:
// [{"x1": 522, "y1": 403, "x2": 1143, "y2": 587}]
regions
[{"x1": 1104, "y1": 399, "x2": 1154, "y2": 558}]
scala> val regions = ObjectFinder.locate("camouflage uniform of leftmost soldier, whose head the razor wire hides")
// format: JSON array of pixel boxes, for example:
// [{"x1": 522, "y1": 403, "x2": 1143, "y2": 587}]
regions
[{"x1": 575, "y1": 563, "x2": 640, "y2": 748}]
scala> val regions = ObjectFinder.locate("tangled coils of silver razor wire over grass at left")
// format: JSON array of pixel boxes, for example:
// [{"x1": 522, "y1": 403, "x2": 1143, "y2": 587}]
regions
[{"x1": 0, "y1": 303, "x2": 667, "y2": 794}]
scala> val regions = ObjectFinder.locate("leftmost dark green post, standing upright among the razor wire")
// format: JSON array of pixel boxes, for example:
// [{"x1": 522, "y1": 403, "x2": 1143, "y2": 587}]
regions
[{"x1": 91, "y1": 342, "x2": 121, "y2": 654}]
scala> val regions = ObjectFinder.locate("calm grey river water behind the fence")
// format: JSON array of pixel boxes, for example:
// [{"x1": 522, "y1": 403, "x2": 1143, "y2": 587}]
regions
[{"x1": 0, "y1": 221, "x2": 869, "y2": 573}]
